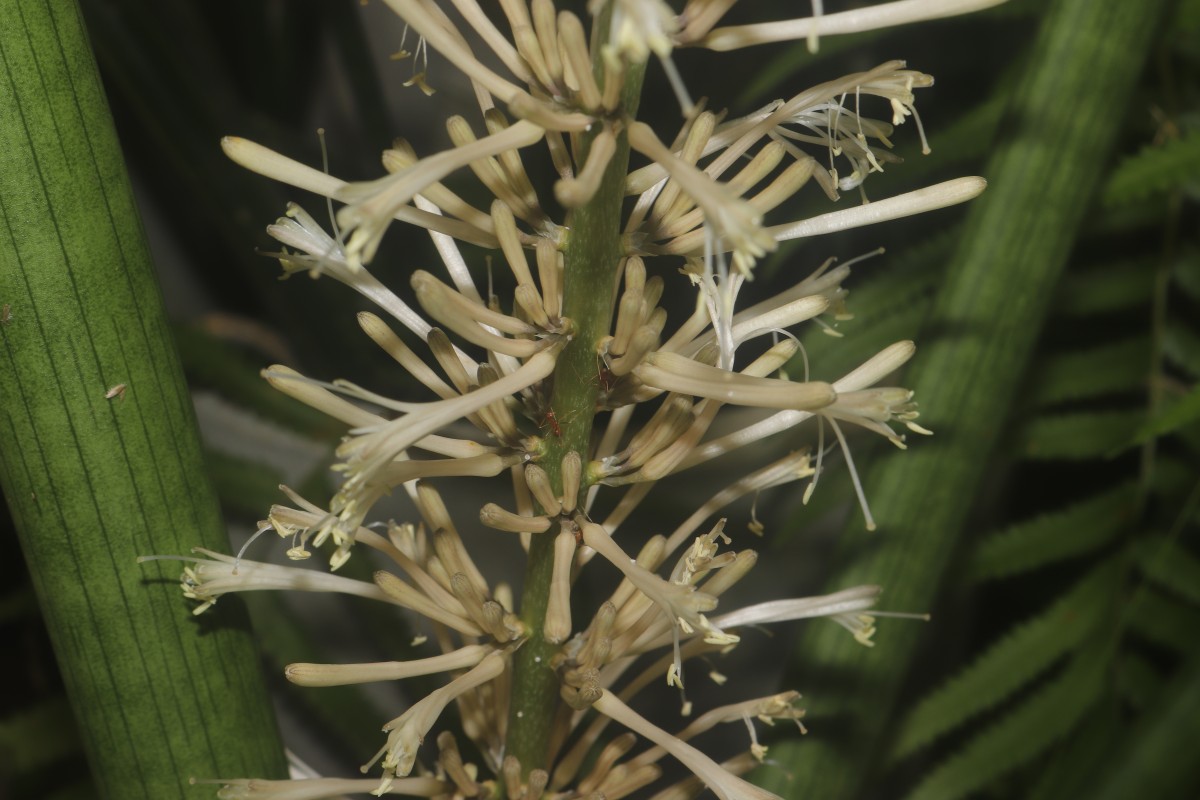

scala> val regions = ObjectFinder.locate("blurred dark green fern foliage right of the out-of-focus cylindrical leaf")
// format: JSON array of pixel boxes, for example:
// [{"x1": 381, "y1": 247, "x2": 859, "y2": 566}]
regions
[{"x1": 893, "y1": 2, "x2": 1200, "y2": 800}]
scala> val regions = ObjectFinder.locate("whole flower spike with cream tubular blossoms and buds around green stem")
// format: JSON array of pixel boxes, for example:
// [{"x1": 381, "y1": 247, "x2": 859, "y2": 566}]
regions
[{"x1": 145, "y1": 0, "x2": 994, "y2": 800}]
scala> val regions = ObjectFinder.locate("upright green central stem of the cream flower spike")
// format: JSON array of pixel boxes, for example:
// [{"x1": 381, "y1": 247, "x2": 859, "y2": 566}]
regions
[{"x1": 508, "y1": 67, "x2": 643, "y2": 774}]
